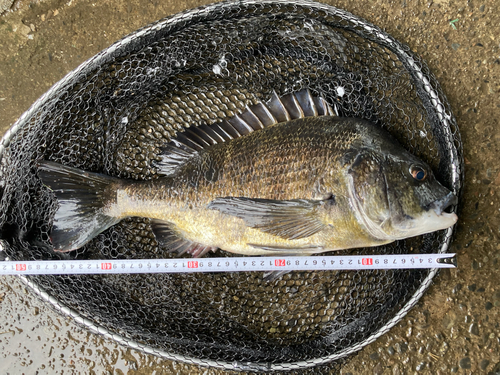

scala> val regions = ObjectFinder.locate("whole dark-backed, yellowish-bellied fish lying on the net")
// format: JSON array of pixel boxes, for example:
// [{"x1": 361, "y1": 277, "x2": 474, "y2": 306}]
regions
[{"x1": 38, "y1": 89, "x2": 458, "y2": 257}]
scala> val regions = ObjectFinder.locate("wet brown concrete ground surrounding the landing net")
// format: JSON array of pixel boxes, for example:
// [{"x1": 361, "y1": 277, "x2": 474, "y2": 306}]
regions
[{"x1": 0, "y1": 0, "x2": 500, "y2": 375}]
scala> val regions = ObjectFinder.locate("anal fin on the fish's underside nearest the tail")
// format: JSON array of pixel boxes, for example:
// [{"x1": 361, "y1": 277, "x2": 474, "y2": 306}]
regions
[{"x1": 152, "y1": 219, "x2": 217, "y2": 258}]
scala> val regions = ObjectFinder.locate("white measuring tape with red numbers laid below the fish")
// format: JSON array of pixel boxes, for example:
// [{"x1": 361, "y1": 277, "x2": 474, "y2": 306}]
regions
[{"x1": 0, "y1": 254, "x2": 456, "y2": 275}]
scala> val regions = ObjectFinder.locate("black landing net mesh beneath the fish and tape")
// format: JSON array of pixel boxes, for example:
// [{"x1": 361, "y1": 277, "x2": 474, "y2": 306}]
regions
[{"x1": 0, "y1": 1, "x2": 462, "y2": 370}]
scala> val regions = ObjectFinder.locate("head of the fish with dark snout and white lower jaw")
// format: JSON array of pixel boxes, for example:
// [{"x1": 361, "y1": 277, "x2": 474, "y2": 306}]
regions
[{"x1": 348, "y1": 146, "x2": 458, "y2": 241}]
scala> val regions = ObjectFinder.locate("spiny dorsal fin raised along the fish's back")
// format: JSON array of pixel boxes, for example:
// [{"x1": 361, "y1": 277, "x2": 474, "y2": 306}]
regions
[{"x1": 155, "y1": 89, "x2": 338, "y2": 175}]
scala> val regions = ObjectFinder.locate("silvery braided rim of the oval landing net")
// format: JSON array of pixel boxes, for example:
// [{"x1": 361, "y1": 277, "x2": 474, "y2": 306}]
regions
[{"x1": 0, "y1": 0, "x2": 461, "y2": 371}]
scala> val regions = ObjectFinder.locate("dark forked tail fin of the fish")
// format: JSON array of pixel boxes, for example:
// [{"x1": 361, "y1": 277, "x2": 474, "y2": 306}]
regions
[{"x1": 38, "y1": 161, "x2": 120, "y2": 252}]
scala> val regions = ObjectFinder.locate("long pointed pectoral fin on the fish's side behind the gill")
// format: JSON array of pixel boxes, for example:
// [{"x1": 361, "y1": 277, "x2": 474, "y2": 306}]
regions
[{"x1": 208, "y1": 197, "x2": 326, "y2": 240}]
